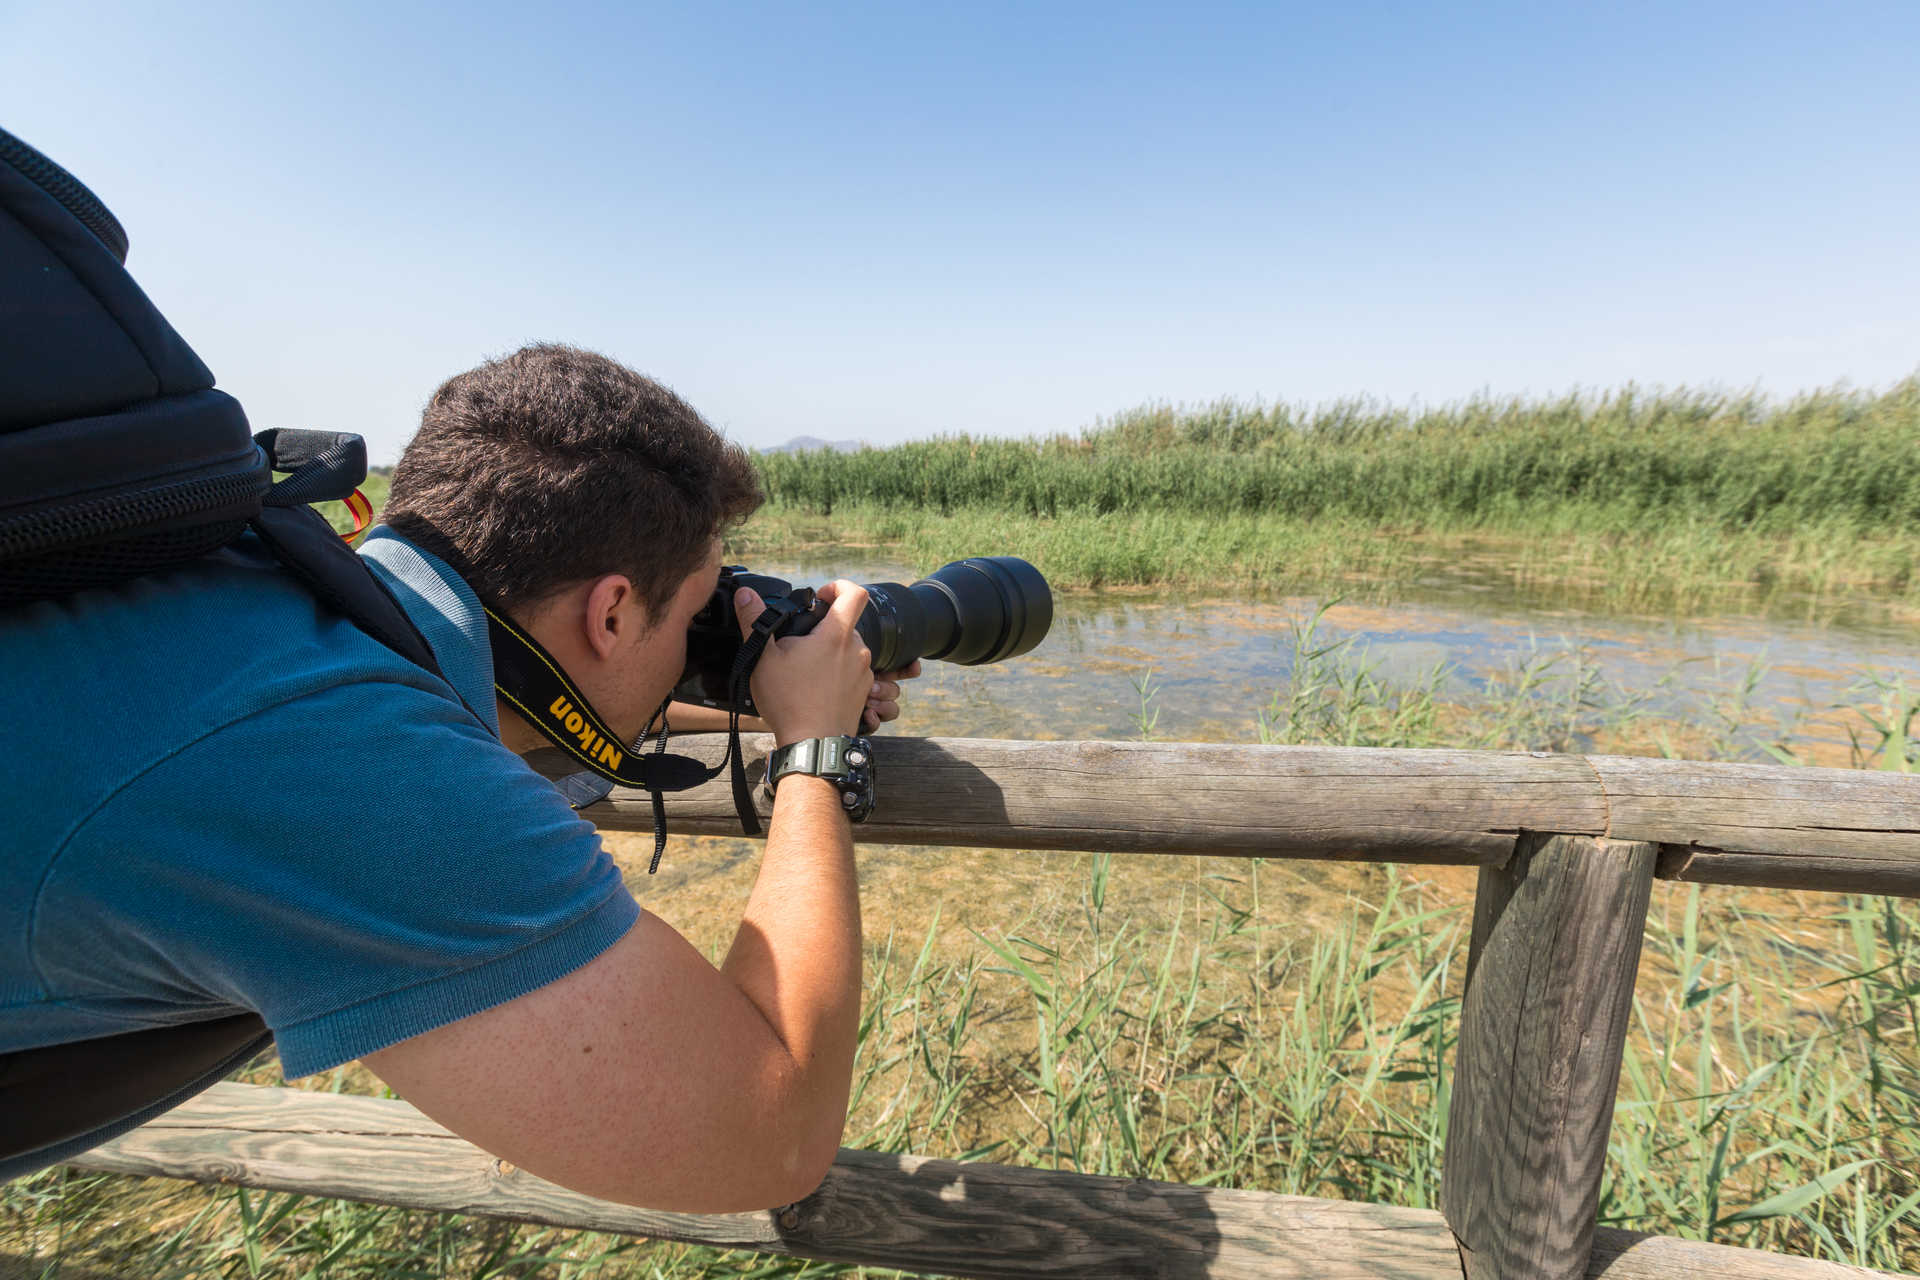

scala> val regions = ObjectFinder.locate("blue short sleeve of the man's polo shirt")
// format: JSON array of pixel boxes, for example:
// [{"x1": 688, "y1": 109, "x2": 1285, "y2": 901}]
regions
[{"x1": 35, "y1": 681, "x2": 639, "y2": 1077}]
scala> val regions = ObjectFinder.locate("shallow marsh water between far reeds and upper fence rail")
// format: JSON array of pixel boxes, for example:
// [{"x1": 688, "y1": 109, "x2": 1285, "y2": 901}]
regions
[{"x1": 737, "y1": 557, "x2": 1920, "y2": 762}]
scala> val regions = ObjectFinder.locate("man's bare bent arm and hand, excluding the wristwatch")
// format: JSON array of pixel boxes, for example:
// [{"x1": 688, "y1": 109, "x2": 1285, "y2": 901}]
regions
[{"x1": 367, "y1": 583, "x2": 872, "y2": 1213}]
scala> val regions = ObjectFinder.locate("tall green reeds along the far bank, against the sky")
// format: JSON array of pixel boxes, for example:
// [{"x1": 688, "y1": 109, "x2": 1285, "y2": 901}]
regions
[{"x1": 760, "y1": 378, "x2": 1920, "y2": 532}]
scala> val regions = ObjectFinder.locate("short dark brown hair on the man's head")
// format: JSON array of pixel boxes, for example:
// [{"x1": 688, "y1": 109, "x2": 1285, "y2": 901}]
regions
[{"x1": 382, "y1": 344, "x2": 764, "y2": 618}]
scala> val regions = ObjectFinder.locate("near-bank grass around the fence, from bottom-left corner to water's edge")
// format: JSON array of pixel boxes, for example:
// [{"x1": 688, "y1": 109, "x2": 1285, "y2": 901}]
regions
[{"x1": 0, "y1": 618, "x2": 1920, "y2": 1280}]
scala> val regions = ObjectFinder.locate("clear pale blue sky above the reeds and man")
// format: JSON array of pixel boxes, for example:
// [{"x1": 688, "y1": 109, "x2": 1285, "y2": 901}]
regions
[{"x1": 0, "y1": 0, "x2": 1920, "y2": 461}]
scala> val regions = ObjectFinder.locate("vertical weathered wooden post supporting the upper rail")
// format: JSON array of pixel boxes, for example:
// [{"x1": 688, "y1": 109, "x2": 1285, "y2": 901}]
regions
[{"x1": 1440, "y1": 833, "x2": 1657, "y2": 1280}]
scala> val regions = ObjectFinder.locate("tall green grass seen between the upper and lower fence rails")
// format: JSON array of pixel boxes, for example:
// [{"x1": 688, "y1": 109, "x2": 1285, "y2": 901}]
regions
[{"x1": 860, "y1": 860, "x2": 1920, "y2": 1268}]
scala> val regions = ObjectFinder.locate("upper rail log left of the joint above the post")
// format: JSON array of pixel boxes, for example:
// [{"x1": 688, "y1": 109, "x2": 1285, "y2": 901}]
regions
[{"x1": 589, "y1": 735, "x2": 1605, "y2": 864}]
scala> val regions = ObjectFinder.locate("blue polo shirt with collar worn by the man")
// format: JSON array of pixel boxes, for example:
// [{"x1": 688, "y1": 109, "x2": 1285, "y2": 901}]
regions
[{"x1": 0, "y1": 530, "x2": 639, "y2": 1077}]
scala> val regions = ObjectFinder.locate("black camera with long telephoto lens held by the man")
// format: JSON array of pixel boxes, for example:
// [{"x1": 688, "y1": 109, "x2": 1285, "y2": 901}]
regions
[{"x1": 674, "y1": 557, "x2": 1054, "y2": 716}]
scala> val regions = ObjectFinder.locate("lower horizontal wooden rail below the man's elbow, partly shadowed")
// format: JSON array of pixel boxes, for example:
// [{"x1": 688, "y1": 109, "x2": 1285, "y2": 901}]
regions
[{"x1": 73, "y1": 1084, "x2": 1887, "y2": 1280}]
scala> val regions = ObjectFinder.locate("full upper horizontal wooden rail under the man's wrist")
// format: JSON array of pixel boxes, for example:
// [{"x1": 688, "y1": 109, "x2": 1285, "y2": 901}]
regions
[{"x1": 568, "y1": 735, "x2": 1920, "y2": 896}]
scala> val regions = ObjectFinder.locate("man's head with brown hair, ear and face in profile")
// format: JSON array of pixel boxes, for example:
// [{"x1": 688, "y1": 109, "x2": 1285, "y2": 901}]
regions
[{"x1": 384, "y1": 345, "x2": 762, "y2": 750}]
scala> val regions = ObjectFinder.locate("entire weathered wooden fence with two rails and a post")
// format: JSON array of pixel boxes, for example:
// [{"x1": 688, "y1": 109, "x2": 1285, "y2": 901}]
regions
[{"x1": 75, "y1": 739, "x2": 1920, "y2": 1280}]
